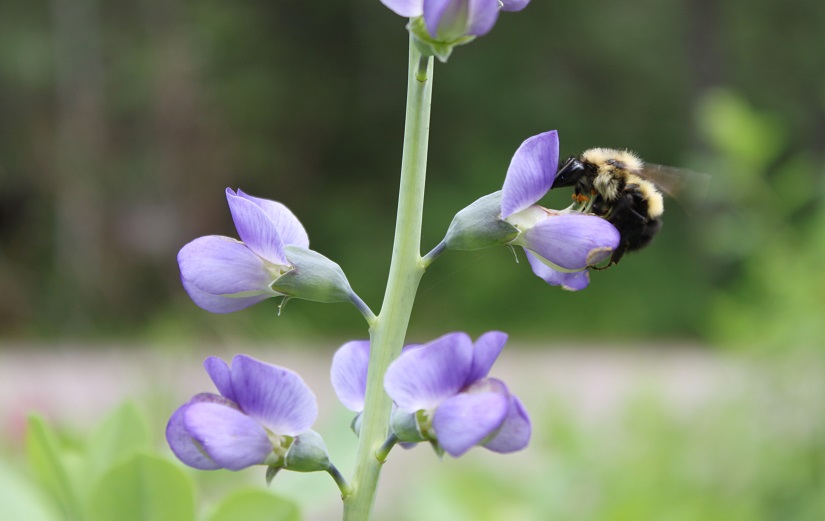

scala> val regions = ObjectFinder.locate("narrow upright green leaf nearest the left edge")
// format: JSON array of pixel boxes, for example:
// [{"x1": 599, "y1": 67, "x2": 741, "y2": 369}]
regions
[{"x1": 26, "y1": 415, "x2": 83, "y2": 521}]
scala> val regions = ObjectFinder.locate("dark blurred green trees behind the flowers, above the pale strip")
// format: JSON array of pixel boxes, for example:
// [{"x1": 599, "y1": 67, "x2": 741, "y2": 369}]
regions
[{"x1": 0, "y1": 0, "x2": 825, "y2": 345}]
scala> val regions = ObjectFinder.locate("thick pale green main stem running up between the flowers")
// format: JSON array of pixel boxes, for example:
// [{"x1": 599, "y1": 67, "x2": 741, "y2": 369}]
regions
[{"x1": 344, "y1": 35, "x2": 433, "y2": 521}]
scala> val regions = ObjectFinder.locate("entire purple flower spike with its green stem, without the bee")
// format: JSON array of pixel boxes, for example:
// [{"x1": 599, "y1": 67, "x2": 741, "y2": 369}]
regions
[{"x1": 166, "y1": 0, "x2": 652, "y2": 519}]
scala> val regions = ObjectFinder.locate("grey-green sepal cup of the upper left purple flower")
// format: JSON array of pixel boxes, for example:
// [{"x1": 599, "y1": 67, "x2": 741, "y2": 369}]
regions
[{"x1": 272, "y1": 246, "x2": 352, "y2": 303}]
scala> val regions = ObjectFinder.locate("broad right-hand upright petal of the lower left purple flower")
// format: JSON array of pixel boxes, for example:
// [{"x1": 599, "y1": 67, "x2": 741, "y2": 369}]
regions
[{"x1": 232, "y1": 355, "x2": 318, "y2": 436}]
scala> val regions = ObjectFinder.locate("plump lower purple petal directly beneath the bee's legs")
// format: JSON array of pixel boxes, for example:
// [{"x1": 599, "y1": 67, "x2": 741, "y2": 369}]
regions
[{"x1": 517, "y1": 214, "x2": 620, "y2": 270}]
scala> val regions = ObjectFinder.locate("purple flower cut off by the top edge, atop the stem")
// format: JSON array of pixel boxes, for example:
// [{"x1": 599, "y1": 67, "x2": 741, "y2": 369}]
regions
[{"x1": 381, "y1": 0, "x2": 530, "y2": 42}]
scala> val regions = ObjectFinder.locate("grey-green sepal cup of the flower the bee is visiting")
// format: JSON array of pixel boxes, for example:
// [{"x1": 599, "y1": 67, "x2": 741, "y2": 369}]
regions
[{"x1": 444, "y1": 190, "x2": 520, "y2": 250}]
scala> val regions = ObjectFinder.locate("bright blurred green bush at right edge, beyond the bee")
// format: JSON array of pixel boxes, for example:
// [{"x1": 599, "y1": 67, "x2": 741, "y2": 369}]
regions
[{"x1": 699, "y1": 91, "x2": 825, "y2": 349}]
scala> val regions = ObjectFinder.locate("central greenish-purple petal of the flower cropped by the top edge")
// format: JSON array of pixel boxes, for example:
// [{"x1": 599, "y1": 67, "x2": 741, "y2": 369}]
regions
[{"x1": 424, "y1": 0, "x2": 499, "y2": 41}]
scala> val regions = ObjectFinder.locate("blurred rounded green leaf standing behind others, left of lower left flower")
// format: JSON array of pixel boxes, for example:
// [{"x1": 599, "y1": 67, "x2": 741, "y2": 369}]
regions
[{"x1": 88, "y1": 401, "x2": 151, "y2": 483}]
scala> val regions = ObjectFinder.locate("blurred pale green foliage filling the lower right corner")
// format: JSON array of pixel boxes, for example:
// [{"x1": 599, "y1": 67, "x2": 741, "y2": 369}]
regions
[{"x1": 396, "y1": 358, "x2": 825, "y2": 521}]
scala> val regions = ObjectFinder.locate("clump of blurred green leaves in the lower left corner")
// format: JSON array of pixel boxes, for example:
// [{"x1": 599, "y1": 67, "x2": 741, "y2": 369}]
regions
[{"x1": 16, "y1": 402, "x2": 300, "y2": 521}]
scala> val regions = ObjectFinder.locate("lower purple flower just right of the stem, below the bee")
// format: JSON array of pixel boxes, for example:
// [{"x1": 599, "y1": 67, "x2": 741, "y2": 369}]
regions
[{"x1": 384, "y1": 331, "x2": 531, "y2": 457}]
